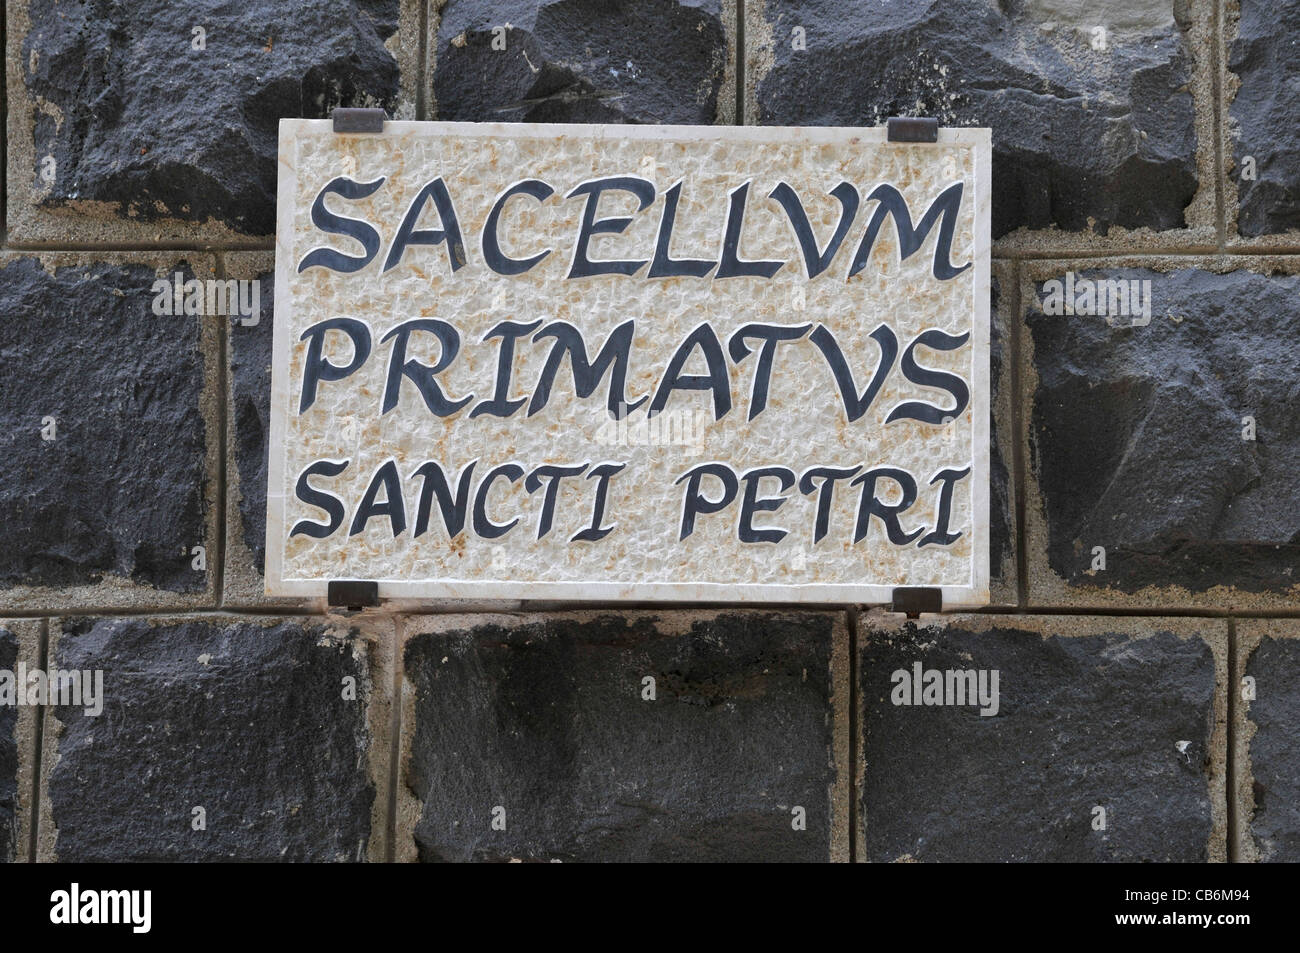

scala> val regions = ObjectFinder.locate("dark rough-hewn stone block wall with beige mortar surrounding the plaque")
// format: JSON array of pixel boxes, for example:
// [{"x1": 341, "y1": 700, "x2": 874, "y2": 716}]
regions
[{"x1": 0, "y1": 0, "x2": 1300, "y2": 861}]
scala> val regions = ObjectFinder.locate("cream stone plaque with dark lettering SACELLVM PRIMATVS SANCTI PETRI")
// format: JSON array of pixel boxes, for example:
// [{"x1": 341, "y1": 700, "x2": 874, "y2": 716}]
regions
[{"x1": 267, "y1": 120, "x2": 991, "y2": 606}]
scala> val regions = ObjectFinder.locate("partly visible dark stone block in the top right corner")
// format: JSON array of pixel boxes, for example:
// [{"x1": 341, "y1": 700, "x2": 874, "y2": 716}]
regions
[{"x1": 1227, "y1": 0, "x2": 1300, "y2": 237}]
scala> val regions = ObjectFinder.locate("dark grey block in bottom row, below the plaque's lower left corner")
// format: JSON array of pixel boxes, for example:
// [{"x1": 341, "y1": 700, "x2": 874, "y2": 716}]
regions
[{"x1": 42, "y1": 619, "x2": 376, "y2": 861}]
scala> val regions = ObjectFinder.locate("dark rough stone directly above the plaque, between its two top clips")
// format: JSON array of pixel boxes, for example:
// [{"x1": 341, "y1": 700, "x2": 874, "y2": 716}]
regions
[{"x1": 433, "y1": 0, "x2": 728, "y2": 125}]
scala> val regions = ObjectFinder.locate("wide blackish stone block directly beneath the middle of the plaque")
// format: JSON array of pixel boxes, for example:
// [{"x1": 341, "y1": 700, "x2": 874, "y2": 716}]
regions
[{"x1": 399, "y1": 614, "x2": 842, "y2": 861}]
